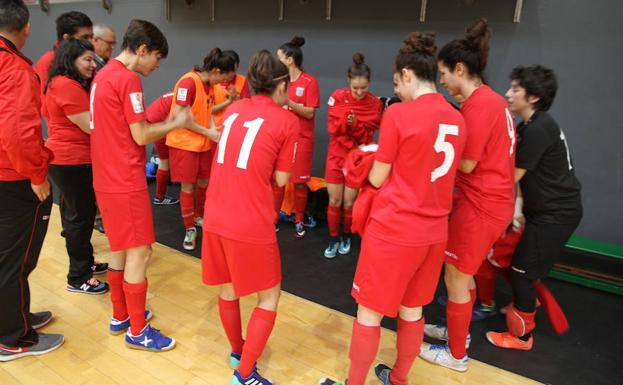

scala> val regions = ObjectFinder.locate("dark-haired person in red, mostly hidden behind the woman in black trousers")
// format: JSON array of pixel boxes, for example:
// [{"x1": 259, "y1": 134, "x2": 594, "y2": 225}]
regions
[{"x1": 35, "y1": 11, "x2": 93, "y2": 120}]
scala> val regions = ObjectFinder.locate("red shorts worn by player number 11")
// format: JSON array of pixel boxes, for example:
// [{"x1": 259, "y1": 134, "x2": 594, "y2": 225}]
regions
[{"x1": 201, "y1": 231, "x2": 281, "y2": 297}]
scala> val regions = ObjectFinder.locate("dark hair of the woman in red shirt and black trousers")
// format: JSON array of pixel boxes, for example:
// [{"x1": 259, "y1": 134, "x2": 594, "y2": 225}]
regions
[{"x1": 43, "y1": 39, "x2": 95, "y2": 93}]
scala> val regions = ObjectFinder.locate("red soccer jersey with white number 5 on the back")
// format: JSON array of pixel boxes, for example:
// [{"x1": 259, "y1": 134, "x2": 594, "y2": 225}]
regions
[{"x1": 366, "y1": 93, "x2": 467, "y2": 246}]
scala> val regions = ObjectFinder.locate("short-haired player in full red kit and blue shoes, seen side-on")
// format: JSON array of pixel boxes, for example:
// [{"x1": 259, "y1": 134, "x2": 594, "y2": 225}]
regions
[{"x1": 91, "y1": 20, "x2": 213, "y2": 351}]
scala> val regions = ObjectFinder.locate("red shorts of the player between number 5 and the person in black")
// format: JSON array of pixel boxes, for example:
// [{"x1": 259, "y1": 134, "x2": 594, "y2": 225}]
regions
[{"x1": 446, "y1": 198, "x2": 508, "y2": 275}]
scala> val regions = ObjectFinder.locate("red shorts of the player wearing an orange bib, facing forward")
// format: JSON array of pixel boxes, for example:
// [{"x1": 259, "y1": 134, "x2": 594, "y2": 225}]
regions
[{"x1": 169, "y1": 147, "x2": 213, "y2": 183}]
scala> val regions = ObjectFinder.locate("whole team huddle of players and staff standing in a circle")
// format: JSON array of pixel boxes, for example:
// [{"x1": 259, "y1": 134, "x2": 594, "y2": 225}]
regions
[{"x1": 0, "y1": 0, "x2": 582, "y2": 385}]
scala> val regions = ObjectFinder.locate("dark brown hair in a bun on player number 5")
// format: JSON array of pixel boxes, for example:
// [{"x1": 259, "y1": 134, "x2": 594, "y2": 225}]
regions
[{"x1": 394, "y1": 32, "x2": 437, "y2": 83}]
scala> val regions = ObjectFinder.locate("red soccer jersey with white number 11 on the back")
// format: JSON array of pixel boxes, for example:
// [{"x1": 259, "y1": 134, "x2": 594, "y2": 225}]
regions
[{"x1": 203, "y1": 95, "x2": 299, "y2": 244}]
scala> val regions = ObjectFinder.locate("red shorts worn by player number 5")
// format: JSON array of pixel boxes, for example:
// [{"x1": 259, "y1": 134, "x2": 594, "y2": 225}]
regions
[{"x1": 351, "y1": 233, "x2": 446, "y2": 317}]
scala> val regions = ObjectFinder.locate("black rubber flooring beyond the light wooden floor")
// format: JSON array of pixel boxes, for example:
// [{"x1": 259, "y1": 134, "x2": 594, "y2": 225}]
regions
[{"x1": 150, "y1": 184, "x2": 623, "y2": 385}]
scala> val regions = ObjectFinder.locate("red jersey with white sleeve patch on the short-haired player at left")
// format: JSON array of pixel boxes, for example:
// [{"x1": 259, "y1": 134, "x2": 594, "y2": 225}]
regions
[{"x1": 91, "y1": 59, "x2": 147, "y2": 193}]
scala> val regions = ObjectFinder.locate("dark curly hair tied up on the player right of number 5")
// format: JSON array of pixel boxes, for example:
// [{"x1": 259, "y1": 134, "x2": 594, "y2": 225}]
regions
[{"x1": 437, "y1": 18, "x2": 491, "y2": 78}]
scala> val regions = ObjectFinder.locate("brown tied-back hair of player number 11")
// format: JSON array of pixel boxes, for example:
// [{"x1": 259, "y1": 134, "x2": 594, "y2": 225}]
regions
[{"x1": 247, "y1": 49, "x2": 290, "y2": 95}]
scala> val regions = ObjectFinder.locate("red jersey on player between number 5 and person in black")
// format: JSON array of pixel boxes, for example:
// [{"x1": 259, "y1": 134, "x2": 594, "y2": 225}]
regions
[{"x1": 456, "y1": 86, "x2": 516, "y2": 224}]
